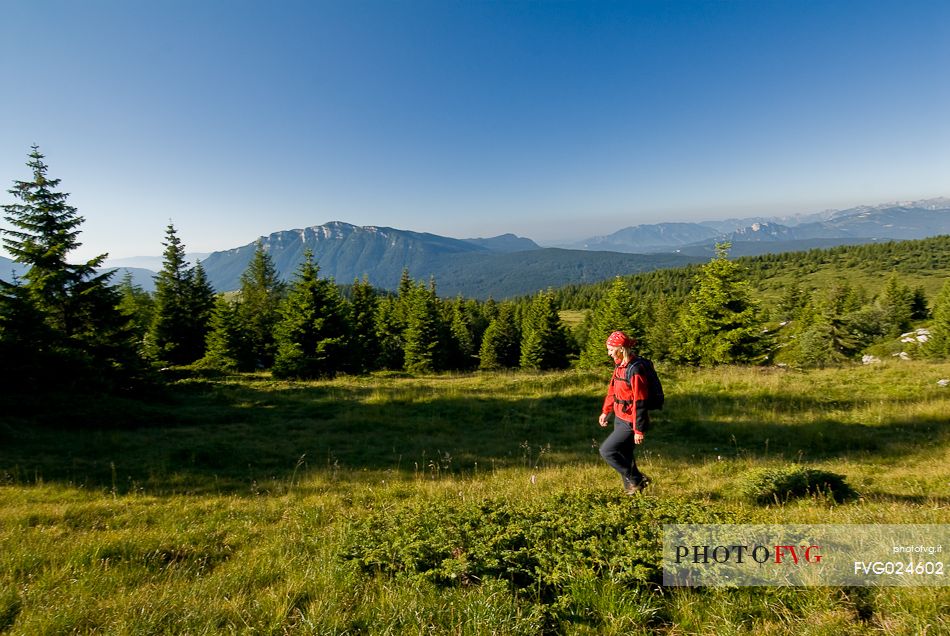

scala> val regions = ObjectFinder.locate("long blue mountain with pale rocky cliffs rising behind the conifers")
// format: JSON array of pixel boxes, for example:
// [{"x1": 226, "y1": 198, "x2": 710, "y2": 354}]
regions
[{"x1": 202, "y1": 221, "x2": 697, "y2": 298}]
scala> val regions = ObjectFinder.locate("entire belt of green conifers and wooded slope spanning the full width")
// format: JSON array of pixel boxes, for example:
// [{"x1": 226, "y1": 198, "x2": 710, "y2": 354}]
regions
[{"x1": 0, "y1": 147, "x2": 950, "y2": 390}]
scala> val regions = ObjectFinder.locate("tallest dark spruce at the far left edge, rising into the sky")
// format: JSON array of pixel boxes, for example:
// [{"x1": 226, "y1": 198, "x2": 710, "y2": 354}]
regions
[{"x1": 2, "y1": 146, "x2": 144, "y2": 389}]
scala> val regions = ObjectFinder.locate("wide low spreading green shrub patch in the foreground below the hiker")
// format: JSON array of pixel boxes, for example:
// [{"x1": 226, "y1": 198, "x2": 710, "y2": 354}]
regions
[{"x1": 343, "y1": 493, "x2": 732, "y2": 602}]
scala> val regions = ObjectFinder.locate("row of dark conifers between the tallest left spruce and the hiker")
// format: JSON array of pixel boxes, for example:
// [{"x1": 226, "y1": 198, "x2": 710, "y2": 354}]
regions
[{"x1": 131, "y1": 226, "x2": 573, "y2": 378}]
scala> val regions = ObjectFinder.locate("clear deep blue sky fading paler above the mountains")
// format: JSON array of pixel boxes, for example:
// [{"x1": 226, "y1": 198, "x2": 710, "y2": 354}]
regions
[{"x1": 0, "y1": 0, "x2": 950, "y2": 258}]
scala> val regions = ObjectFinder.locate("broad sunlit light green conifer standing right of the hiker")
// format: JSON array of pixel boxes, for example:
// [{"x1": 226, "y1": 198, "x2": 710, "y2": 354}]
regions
[{"x1": 678, "y1": 243, "x2": 762, "y2": 366}]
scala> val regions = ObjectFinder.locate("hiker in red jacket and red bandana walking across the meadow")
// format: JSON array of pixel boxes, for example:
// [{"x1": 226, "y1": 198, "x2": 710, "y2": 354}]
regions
[{"x1": 598, "y1": 331, "x2": 650, "y2": 495}]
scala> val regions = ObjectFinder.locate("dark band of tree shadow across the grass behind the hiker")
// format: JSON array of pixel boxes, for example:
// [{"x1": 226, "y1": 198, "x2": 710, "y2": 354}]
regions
[{"x1": 0, "y1": 379, "x2": 950, "y2": 494}]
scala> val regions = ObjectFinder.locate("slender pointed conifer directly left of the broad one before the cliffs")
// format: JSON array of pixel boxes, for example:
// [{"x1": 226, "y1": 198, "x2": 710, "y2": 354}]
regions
[{"x1": 238, "y1": 241, "x2": 287, "y2": 368}]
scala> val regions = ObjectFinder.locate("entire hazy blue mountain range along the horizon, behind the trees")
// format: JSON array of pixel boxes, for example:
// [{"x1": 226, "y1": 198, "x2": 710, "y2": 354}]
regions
[{"x1": 0, "y1": 198, "x2": 950, "y2": 299}]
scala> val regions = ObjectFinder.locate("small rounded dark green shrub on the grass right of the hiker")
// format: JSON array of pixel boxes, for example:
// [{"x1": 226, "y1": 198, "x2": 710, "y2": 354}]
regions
[{"x1": 740, "y1": 465, "x2": 857, "y2": 504}]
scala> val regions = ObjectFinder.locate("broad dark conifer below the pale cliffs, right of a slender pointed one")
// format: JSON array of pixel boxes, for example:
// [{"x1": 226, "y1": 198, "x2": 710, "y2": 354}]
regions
[{"x1": 273, "y1": 249, "x2": 349, "y2": 378}]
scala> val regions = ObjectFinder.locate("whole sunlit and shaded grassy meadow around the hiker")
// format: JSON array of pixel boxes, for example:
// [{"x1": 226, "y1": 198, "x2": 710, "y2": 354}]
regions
[{"x1": 0, "y1": 361, "x2": 950, "y2": 636}]
